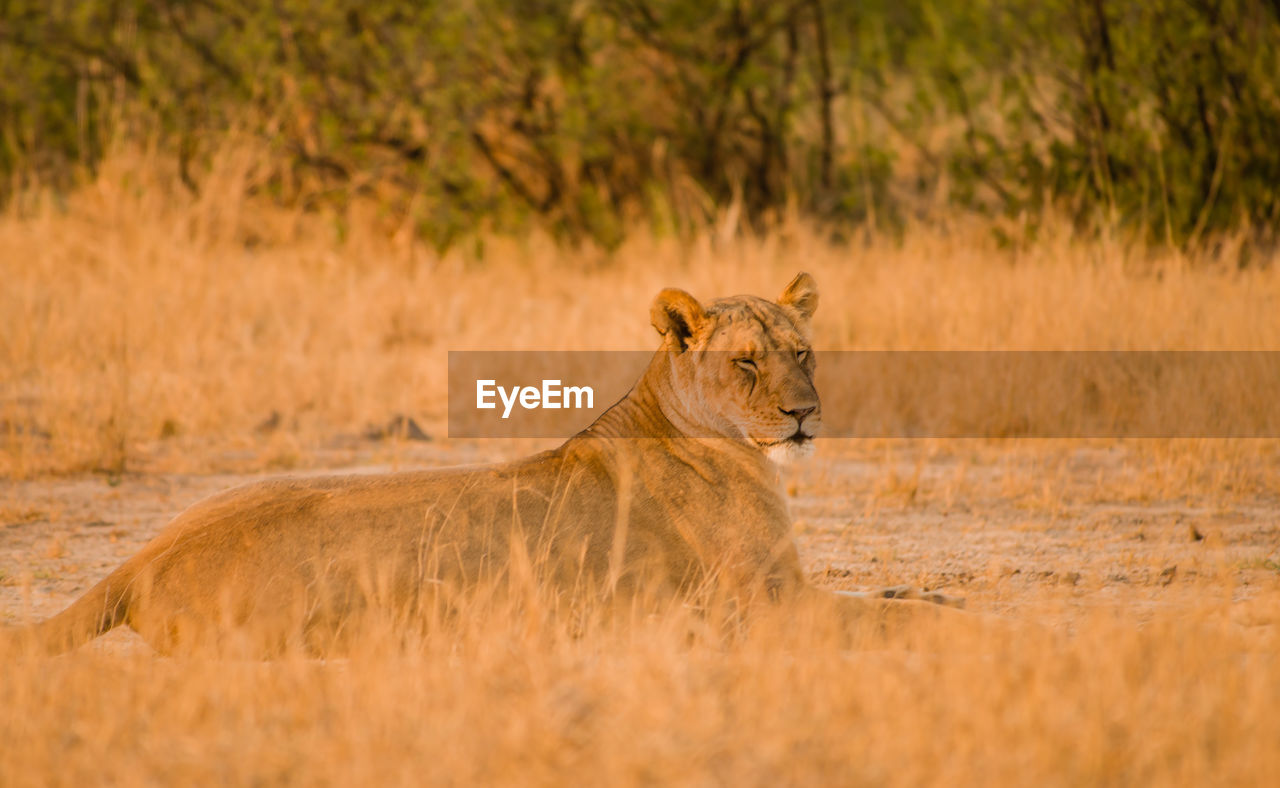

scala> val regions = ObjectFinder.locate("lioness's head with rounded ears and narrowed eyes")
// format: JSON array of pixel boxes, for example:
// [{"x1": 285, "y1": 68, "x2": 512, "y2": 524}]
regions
[{"x1": 650, "y1": 274, "x2": 822, "y2": 462}]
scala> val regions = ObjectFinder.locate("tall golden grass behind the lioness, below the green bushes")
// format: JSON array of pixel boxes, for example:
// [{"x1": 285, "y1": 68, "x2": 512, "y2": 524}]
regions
[{"x1": 0, "y1": 150, "x2": 1280, "y2": 475}]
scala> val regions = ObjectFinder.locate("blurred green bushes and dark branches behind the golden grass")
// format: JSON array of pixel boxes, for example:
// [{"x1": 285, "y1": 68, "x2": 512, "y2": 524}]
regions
[{"x1": 0, "y1": 0, "x2": 1280, "y2": 247}]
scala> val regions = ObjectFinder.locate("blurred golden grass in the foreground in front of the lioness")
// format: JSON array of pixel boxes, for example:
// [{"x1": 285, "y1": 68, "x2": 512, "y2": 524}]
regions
[{"x1": 0, "y1": 593, "x2": 1280, "y2": 785}]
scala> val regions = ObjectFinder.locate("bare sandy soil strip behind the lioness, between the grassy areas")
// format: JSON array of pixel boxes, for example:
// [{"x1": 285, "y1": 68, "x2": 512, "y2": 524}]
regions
[{"x1": 0, "y1": 441, "x2": 1280, "y2": 650}]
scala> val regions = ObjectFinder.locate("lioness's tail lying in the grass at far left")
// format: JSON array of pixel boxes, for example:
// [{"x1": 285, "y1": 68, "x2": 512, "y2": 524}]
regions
[{"x1": 0, "y1": 562, "x2": 134, "y2": 655}]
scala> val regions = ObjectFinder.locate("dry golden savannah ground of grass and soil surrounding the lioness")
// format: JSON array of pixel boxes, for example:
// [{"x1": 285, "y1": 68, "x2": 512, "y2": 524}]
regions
[{"x1": 0, "y1": 155, "x2": 1280, "y2": 785}]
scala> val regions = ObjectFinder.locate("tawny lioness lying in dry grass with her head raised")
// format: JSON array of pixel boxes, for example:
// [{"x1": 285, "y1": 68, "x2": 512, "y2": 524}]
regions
[{"x1": 2, "y1": 274, "x2": 962, "y2": 654}]
